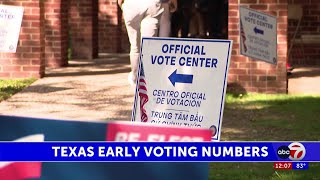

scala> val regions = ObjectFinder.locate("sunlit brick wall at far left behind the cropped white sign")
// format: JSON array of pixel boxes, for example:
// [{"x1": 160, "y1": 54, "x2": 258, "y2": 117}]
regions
[{"x1": 0, "y1": 0, "x2": 45, "y2": 78}]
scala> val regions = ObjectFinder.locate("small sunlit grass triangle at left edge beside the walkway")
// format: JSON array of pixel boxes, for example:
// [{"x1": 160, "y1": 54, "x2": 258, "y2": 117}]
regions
[{"x1": 0, "y1": 78, "x2": 36, "y2": 102}]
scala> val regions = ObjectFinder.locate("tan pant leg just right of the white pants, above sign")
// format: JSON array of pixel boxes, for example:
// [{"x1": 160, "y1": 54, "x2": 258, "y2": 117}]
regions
[{"x1": 159, "y1": 3, "x2": 171, "y2": 37}]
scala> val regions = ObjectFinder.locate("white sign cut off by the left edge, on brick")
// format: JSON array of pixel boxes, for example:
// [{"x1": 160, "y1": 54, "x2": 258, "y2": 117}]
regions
[{"x1": 0, "y1": 5, "x2": 23, "y2": 53}]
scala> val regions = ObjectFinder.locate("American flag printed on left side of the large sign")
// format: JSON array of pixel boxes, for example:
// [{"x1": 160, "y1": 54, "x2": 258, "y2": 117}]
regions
[{"x1": 139, "y1": 64, "x2": 149, "y2": 122}]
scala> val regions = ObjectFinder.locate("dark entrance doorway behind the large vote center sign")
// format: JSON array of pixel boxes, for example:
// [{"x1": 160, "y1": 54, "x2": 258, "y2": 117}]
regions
[{"x1": 171, "y1": 0, "x2": 228, "y2": 39}]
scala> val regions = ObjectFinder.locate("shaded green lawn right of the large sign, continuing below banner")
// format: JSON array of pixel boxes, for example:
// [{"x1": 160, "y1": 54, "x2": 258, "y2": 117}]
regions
[{"x1": 209, "y1": 94, "x2": 320, "y2": 179}]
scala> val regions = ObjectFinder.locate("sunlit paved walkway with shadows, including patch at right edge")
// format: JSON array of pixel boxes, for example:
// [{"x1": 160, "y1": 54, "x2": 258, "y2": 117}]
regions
[{"x1": 0, "y1": 54, "x2": 320, "y2": 121}]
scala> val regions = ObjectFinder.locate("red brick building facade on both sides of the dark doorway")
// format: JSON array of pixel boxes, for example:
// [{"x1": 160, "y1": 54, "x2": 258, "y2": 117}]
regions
[{"x1": 0, "y1": 0, "x2": 320, "y2": 93}]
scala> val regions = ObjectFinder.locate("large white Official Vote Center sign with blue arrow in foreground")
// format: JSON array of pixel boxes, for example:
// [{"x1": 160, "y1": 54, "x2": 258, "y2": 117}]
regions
[{"x1": 132, "y1": 38, "x2": 232, "y2": 141}]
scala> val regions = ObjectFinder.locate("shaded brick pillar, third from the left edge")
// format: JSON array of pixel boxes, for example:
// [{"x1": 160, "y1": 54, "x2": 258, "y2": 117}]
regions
[{"x1": 69, "y1": 0, "x2": 98, "y2": 59}]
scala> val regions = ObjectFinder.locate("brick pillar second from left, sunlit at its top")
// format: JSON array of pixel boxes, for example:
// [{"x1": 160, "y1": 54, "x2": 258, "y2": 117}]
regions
[{"x1": 44, "y1": 0, "x2": 69, "y2": 67}]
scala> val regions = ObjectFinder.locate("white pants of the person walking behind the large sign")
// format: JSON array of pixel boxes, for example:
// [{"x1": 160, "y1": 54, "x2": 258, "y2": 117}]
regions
[{"x1": 122, "y1": 0, "x2": 163, "y2": 84}]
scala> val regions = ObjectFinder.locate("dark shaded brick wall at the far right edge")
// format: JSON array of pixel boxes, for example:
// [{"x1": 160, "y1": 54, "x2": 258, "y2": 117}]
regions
[{"x1": 288, "y1": 0, "x2": 320, "y2": 66}]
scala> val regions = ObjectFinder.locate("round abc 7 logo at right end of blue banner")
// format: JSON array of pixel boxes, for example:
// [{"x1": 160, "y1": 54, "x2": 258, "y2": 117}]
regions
[{"x1": 277, "y1": 142, "x2": 306, "y2": 161}]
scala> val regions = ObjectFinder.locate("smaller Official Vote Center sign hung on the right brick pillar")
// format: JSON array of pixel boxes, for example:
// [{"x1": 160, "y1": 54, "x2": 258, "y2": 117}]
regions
[{"x1": 240, "y1": 7, "x2": 278, "y2": 64}]
